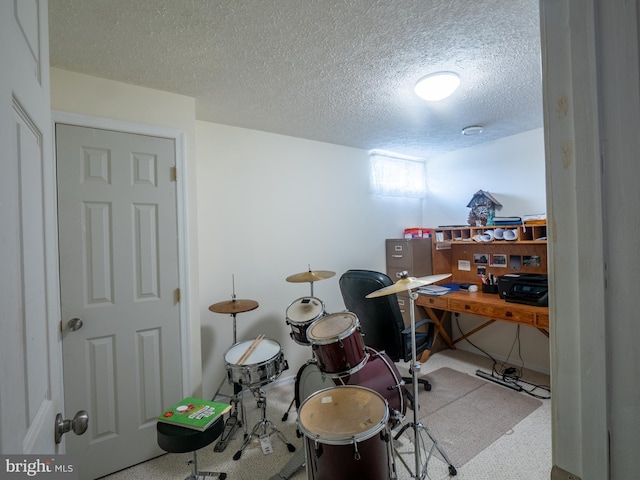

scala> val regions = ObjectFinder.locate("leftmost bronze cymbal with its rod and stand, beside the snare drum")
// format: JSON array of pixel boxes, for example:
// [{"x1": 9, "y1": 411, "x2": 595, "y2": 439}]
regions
[{"x1": 209, "y1": 275, "x2": 258, "y2": 452}]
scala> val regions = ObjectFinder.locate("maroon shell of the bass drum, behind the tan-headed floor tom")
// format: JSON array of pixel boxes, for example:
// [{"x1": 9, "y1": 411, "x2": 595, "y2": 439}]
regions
[{"x1": 334, "y1": 347, "x2": 407, "y2": 422}]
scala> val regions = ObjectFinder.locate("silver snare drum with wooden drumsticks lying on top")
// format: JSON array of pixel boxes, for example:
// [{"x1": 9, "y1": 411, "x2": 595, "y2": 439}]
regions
[{"x1": 224, "y1": 338, "x2": 287, "y2": 387}]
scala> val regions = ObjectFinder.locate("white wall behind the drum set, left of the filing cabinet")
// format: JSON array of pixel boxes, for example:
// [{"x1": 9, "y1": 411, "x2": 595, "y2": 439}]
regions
[{"x1": 196, "y1": 122, "x2": 422, "y2": 396}]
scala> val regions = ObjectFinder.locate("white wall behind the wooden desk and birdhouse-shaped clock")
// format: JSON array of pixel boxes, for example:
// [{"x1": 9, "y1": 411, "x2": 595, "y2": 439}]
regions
[{"x1": 423, "y1": 129, "x2": 549, "y2": 372}]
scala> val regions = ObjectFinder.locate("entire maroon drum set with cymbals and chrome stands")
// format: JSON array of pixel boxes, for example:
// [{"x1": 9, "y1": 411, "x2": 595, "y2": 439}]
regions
[{"x1": 210, "y1": 268, "x2": 457, "y2": 480}]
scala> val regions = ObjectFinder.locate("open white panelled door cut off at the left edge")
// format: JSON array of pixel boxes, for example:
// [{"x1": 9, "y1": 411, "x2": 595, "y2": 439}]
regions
[{"x1": 0, "y1": 0, "x2": 62, "y2": 454}]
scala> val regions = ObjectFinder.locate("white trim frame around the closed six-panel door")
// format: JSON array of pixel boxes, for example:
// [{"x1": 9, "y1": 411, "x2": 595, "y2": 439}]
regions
[{"x1": 51, "y1": 110, "x2": 193, "y2": 396}]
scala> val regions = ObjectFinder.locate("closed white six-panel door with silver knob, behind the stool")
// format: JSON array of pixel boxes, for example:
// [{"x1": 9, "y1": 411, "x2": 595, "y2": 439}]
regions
[{"x1": 56, "y1": 124, "x2": 182, "y2": 479}]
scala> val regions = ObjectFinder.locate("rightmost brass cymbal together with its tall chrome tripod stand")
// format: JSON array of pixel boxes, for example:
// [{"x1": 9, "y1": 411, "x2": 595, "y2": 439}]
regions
[{"x1": 365, "y1": 272, "x2": 458, "y2": 480}]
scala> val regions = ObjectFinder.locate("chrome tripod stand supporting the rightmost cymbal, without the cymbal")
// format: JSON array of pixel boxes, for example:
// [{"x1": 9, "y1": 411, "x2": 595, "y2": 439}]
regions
[{"x1": 394, "y1": 289, "x2": 458, "y2": 480}]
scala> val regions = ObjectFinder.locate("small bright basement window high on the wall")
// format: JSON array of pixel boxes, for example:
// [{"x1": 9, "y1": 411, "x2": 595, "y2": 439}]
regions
[{"x1": 369, "y1": 151, "x2": 427, "y2": 198}]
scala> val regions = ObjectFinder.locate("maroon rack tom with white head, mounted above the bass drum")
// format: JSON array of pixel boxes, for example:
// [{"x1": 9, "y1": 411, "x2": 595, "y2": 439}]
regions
[{"x1": 307, "y1": 312, "x2": 369, "y2": 377}]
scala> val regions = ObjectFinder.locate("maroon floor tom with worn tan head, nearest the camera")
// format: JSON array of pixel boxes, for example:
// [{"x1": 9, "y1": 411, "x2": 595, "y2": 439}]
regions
[{"x1": 298, "y1": 385, "x2": 394, "y2": 480}]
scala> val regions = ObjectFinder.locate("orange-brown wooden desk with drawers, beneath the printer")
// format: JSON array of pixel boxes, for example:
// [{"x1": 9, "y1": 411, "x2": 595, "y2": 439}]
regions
[{"x1": 415, "y1": 291, "x2": 549, "y2": 362}]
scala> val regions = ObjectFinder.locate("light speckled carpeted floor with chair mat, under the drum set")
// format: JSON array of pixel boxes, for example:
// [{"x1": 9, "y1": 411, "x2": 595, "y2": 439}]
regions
[{"x1": 104, "y1": 350, "x2": 551, "y2": 480}]
